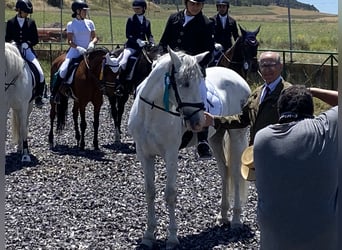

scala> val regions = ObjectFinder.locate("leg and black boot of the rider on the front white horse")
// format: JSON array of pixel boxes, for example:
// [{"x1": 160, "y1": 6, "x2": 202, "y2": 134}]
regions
[{"x1": 197, "y1": 78, "x2": 211, "y2": 159}]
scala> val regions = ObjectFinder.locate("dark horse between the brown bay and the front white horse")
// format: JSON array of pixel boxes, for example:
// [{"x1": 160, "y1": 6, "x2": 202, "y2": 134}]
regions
[{"x1": 108, "y1": 45, "x2": 162, "y2": 142}]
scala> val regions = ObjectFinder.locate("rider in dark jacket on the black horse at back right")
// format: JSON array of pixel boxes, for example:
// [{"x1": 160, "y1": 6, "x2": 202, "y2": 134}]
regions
[{"x1": 212, "y1": 0, "x2": 239, "y2": 51}]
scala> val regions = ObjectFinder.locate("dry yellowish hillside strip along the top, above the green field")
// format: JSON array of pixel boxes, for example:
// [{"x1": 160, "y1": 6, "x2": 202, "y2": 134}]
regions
[{"x1": 5, "y1": 0, "x2": 338, "y2": 23}]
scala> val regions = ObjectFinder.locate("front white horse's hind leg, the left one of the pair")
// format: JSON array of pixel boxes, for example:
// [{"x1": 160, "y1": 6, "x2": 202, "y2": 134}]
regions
[{"x1": 209, "y1": 129, "x2": 230, "y2": 224}]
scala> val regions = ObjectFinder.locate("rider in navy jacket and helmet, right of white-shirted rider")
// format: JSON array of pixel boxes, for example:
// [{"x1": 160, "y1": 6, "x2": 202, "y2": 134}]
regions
[{"x1": 112, "y1": 0, "x2": 154, "y2": 95}]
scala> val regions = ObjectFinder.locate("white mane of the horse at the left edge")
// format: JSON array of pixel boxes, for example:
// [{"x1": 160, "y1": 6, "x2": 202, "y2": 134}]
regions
[{"x1": 5, "y1": 43, "x2": 25, "y2": 78}]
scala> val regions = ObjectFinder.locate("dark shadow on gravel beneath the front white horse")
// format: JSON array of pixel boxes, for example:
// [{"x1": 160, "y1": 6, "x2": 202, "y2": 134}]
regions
[{"x1": 135, "y1": 225, "x2": 254, "y2": 250}]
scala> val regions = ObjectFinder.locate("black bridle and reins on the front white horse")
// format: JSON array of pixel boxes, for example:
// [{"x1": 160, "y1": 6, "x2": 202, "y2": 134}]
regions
[{"x1": 140, "y1": 65, "x2": 205, "y2": 121}]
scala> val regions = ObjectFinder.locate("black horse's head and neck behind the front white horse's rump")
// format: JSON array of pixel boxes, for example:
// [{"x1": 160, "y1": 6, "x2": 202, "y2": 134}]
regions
[{"x1": 217, "y1": 25, "x2": 260, "y2": 79}]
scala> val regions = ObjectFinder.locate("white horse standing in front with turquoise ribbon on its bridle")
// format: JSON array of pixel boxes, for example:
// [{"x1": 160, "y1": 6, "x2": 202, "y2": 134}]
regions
[{"x1": 128, "y1": 47, "x2": 250, "y2": 247}]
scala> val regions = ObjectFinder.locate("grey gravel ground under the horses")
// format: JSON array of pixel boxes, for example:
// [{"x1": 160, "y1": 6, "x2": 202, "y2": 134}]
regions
[{"x1": 5, "y1": 96, "x2": 260, "y2": 250}]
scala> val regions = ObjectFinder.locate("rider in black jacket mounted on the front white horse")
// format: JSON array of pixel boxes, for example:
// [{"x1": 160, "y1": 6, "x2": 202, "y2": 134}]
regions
[{"x1": 159, "y1": 0, "x2": 215, "y2": 159}]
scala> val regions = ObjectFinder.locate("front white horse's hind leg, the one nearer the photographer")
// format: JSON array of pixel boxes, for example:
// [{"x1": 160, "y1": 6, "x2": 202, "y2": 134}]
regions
[{"x1": 226, "y1": 128, "x2": 248, "y2": 228}]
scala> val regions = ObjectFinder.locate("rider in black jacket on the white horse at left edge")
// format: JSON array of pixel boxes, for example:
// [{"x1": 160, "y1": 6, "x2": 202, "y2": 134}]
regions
[{"x1": 5, "y1": 0, "x2": 45, "y2": 108}]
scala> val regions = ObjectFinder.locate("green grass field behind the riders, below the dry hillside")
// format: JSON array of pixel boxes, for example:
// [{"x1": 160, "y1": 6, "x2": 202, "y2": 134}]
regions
[{"x1": 5, "y1": 4, "x2": 338, "y2": 51}]
